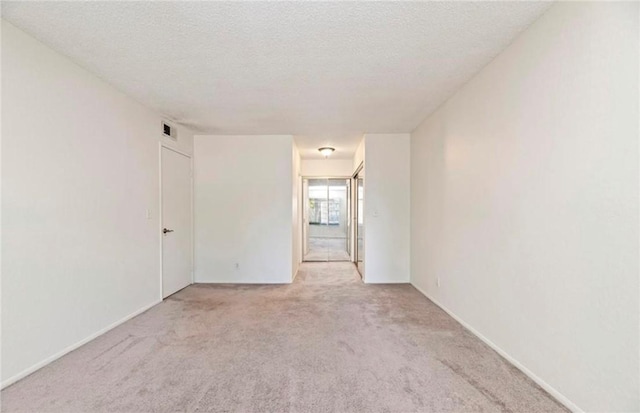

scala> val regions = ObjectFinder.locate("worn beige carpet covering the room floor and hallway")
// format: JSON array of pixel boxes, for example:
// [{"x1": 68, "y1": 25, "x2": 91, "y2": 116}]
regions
[{"x1": 2, "y1": 263, "x2": 565, "y2": 412}]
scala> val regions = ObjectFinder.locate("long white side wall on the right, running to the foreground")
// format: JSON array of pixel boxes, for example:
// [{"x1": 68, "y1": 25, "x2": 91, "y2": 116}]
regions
[{"x1": 410, "y1": 3, "x2": 640, "y2": 411}]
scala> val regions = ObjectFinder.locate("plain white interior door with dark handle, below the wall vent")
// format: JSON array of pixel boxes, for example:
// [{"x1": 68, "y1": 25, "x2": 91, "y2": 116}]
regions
[{"x1": 160, "y1": 147, "x2": 192, "y2": 298}]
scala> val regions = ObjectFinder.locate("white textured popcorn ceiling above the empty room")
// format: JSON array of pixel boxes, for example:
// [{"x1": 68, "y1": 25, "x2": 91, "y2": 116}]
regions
[{"x1": 2, "y1": 1, "x2": 550, "y2": 158}]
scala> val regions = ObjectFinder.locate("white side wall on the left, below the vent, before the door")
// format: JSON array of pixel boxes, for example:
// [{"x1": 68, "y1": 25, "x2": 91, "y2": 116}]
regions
[{"x1": 2, "y1": 21, "x2": 193, "y2": 386}]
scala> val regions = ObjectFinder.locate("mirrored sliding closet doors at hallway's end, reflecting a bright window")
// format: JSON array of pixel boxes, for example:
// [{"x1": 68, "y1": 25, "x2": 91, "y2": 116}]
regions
[{"x1": 302, "y1": 178, "x2": 352, "y2": 262}]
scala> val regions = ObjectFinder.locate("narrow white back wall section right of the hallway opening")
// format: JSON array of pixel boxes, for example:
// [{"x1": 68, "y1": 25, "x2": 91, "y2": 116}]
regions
[{"x1": 358, "y1": 133, "x2": 410, "y2": 283}]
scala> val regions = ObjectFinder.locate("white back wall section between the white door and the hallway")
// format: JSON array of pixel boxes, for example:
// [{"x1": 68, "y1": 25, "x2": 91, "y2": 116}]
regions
[{"x1": 194, "y1": 135, "x2": 294, "y2": 283}]
